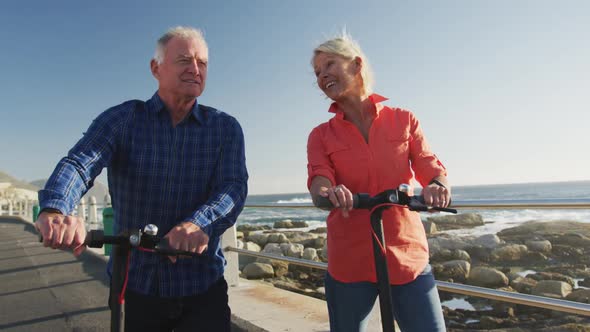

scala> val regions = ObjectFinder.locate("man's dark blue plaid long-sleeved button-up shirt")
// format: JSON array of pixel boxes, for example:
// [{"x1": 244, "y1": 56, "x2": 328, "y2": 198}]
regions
[{"x1": 39, "y1": 93, "x2": 248, "y2": 297}]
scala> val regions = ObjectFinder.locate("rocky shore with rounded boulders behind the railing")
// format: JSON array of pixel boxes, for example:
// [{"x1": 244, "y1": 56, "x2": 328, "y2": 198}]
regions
[{"x1": 238, "y1": 214, "x2": 590, "y2": 331}]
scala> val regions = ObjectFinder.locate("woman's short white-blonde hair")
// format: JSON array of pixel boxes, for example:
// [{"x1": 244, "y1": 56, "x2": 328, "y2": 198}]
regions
[{"x1": 311, "y1": 31, "x2": 375, "y2": 94}]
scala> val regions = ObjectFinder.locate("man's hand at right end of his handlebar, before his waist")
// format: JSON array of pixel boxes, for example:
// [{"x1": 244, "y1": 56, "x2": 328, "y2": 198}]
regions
[{"x1": 164, "y1": 221, "x2": 209, "y2": 263}]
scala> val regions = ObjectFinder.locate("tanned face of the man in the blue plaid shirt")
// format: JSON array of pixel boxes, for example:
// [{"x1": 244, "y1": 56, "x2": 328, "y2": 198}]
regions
[{"x1": 152, "y1": 37, "x2": 208, "y2": 98}]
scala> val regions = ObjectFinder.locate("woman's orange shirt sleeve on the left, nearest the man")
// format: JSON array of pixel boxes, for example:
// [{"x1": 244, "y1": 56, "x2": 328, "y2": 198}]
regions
[{"x1": 307, "y1": 126, "x2": 336, "y2": 189}]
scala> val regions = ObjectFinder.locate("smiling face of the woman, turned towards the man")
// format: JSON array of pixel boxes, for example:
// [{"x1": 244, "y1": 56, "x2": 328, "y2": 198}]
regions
[{"x1": 313, "y1": 52, "x2": 362, "y2": 101}]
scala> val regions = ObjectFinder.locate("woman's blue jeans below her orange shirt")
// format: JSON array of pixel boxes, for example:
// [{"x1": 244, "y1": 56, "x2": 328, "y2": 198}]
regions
[{"x1": 325, "y1": 265, "x2": 446, "y2": 332}]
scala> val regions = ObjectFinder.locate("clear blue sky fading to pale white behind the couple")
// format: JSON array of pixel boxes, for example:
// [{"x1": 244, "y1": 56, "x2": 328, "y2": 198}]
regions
[{"x1": 0, "y1": 0, "x2": 590, "y2": 194}]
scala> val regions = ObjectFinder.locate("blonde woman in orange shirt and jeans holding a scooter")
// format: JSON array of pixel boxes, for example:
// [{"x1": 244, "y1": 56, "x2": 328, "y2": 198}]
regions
[{"x1": 307, "y1": 34, "x2": 451, "y2": 332}]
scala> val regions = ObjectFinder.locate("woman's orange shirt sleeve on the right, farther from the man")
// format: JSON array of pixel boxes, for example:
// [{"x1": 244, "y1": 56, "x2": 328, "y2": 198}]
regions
[{"x1": 409, "y1": 113, "x2": 447, "y2": 186}]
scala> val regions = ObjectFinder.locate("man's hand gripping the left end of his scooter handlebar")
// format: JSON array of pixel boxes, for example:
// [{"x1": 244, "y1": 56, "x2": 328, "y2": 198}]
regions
[{"x1": 35, "y1": 212, "x2": 86, "y2": 256}]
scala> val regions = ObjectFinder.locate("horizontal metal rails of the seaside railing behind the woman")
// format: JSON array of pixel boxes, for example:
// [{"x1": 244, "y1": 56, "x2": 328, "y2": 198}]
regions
[{"x1": 225, "y1": 201, "x2": 590, "y2": 316}]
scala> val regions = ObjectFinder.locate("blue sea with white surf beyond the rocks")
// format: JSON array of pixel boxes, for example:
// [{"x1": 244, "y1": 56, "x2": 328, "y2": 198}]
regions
[{"x1": 237, "y1": 180, "x2": 590, "y2": 236}]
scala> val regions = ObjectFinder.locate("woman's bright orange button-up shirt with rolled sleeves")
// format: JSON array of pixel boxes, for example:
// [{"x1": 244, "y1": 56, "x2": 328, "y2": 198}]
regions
[{"x1": 307, "y1": 94, "x2": 446, "y2": 284}]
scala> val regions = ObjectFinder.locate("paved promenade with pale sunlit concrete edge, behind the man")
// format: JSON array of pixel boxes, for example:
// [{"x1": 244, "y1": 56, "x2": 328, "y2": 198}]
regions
[{"x1": 0, "y1": 216, "x2": 352, "y2": 332}]
